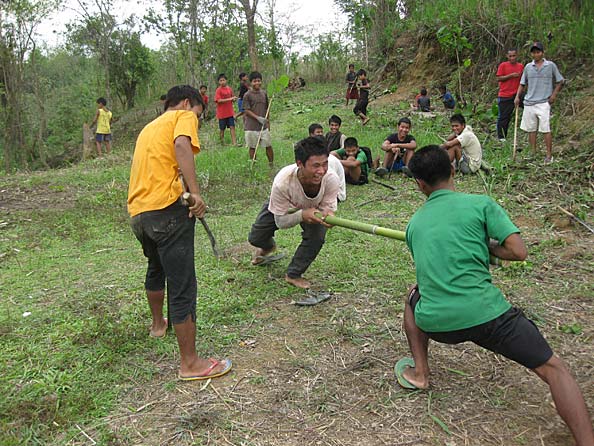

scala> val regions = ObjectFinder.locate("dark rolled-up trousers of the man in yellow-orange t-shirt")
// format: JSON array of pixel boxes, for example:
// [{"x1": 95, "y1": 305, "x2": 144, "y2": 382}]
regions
[{"x1": 130, "y1": 201, "x2": 197, "y2": 324}]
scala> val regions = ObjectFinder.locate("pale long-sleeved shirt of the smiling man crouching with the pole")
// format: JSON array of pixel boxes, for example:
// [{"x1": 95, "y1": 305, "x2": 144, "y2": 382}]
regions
[{"x1": 268, "y1": 164, "x2": 342, "y2": 215}]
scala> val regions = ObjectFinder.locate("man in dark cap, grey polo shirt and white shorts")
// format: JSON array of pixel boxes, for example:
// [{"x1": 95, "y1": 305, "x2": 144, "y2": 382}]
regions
[{"x1": 514, "y1": 42, "x2": 565, "y2": 164}]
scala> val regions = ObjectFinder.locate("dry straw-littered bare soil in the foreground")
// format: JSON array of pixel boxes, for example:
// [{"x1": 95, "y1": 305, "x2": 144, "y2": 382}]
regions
[{"x1": 99, "y1": 256, "x2": 594, "y2": 446}]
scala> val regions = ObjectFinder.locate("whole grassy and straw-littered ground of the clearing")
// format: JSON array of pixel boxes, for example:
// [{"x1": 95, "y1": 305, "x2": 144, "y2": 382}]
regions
[{"x1": 0, "y1": 86, "x2": 594, "y2": 445}]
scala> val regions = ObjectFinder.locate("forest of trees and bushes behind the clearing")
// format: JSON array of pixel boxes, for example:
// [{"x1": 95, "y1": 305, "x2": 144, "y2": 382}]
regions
[{"x1": 0, "y1": 0, "x2": 594, "y2": 172}]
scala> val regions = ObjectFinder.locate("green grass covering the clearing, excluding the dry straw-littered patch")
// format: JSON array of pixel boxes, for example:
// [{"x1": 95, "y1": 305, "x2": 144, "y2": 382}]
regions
[{"x1": 0, "y1": 86, "x2": 588, "y2": 445}]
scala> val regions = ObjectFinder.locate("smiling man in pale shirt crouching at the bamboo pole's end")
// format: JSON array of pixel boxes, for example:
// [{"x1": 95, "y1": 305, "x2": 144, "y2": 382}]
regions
[{"x1": 248, "y1": 137, "x2": 338, "y2": 289}]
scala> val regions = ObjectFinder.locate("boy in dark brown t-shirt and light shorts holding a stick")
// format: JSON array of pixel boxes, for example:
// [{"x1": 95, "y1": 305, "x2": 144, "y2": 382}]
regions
[{"x1": 243, "y1": 71, "x2": 274, "y2": 167}]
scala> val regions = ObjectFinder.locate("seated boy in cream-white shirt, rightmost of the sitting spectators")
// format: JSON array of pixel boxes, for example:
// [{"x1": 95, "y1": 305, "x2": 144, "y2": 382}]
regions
[{"x1": 440, "y1": 114, "x2": 483, "y2": 175}]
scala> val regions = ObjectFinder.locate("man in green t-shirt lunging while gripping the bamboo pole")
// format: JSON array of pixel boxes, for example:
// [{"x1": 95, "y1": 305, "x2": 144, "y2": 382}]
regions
[{"x1": 396, "y1": 146, "x2": 594, "y2": 445}]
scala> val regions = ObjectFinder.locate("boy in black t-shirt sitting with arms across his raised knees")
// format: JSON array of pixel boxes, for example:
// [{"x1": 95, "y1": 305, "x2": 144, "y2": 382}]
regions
[{"x1": 375, "y1": 118, "x2": 417, "y2": 177}]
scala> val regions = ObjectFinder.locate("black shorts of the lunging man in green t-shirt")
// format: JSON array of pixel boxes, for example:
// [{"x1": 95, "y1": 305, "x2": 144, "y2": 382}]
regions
[{"x1": 408, "y1": 288, "x2": 553, "y2": 369}]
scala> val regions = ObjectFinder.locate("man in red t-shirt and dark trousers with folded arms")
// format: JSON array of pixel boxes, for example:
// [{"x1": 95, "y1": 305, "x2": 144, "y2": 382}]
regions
[{"x1": 496, "y1": 48, "x2": 524, "y2": 142}]
